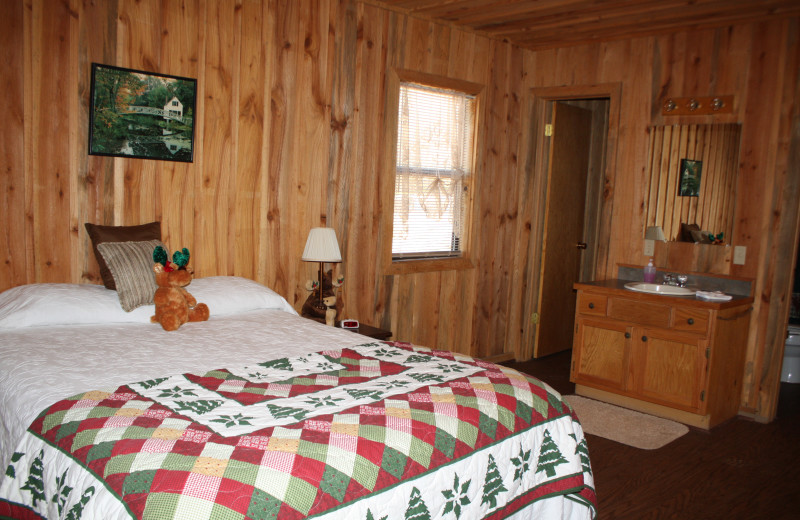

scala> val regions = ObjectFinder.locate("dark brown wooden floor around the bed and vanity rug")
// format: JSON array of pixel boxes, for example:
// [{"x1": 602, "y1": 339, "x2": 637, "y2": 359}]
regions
[{"x1": 503, "y1": 351, "x2": 800, "y2": 520}]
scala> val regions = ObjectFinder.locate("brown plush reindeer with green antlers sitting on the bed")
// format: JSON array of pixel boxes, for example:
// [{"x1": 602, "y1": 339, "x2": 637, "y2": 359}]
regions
[{"x1": 150, "y1": 246, "x2": 209, "y2": 331}]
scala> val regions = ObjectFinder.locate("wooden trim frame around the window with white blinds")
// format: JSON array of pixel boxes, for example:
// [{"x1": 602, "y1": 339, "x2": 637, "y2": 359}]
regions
[{"x1": 381, "y1": 69, "x2": 484, "y2": 274}]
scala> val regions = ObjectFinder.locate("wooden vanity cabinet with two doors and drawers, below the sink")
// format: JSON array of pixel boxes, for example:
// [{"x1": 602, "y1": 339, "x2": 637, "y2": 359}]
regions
[{"x1": 571, "y1": 282, "x2": 752, "y2": 428}]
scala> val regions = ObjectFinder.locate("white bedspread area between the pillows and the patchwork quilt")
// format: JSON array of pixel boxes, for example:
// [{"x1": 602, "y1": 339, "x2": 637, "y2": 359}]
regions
[{"x1": 0, "y1": 310, "x2": 374, "y2": 468}]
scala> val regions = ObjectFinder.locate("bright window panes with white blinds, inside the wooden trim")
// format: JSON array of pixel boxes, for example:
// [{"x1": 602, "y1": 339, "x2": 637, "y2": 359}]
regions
[{"x1": 391, "y1": 79, "x2": 477, "y2": 261}]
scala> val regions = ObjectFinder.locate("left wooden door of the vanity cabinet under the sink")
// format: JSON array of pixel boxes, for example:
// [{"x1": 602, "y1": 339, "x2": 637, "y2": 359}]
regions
[{"x1": 572, "y1": 318, "x2": 631, "y2": 390}]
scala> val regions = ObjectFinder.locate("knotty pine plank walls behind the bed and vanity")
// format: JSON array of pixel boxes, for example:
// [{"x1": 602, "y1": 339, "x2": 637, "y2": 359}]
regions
[{"x1": 0, "y1": 0, "x2": 800, "y2": 420}]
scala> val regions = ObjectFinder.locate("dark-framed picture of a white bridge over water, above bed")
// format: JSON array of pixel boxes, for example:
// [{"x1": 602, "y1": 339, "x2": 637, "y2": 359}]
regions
[{"x1": 89, "y1": 63, "x2": 197, "y2": 162}]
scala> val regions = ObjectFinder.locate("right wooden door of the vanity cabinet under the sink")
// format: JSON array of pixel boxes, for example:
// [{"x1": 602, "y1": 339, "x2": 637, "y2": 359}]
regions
[{"x1": 629, "y1": 328, "x2": 708, "y2": 413}]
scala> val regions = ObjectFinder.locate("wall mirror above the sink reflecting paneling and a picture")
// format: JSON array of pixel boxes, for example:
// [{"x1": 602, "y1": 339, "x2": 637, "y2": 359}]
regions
[{"x1": 644, "y1": 123, "x2": 741, "y2": 244}]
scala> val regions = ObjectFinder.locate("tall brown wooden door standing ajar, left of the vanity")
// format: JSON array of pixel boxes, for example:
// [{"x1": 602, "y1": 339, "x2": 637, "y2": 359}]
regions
[{"x1": 533, "y1": 102, "x2": 592, "y2": 357}]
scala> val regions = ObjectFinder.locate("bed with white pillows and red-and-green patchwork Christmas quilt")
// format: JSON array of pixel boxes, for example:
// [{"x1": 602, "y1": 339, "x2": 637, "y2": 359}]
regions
[{"x1": 0, "y1": 277, "x2": 596, "y2": 520}]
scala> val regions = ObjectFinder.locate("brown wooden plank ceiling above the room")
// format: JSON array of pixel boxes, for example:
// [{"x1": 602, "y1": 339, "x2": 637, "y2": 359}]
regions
[{"x1": 364, "y1": 0, "x2": 800, "y2": 50}]
